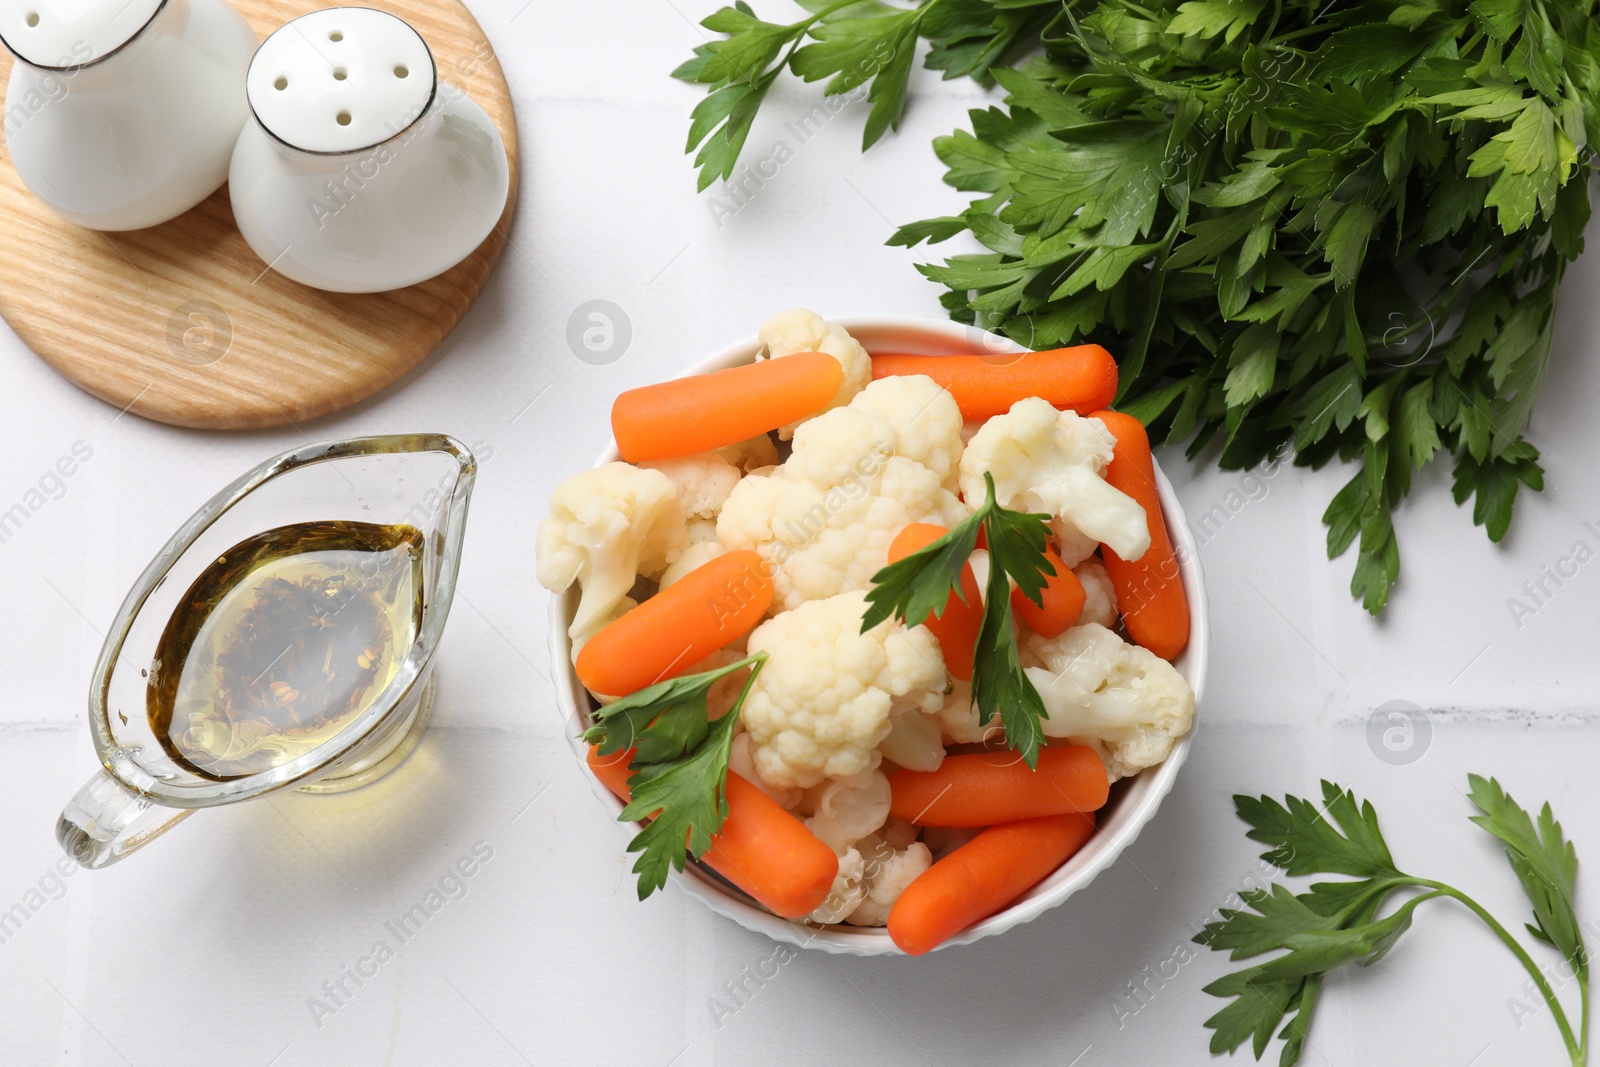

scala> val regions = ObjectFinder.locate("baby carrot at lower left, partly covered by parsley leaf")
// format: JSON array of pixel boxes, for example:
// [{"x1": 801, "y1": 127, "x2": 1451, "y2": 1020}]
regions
[{"x1": 589, "y1": 748, "x2": 838, "y2": 918}]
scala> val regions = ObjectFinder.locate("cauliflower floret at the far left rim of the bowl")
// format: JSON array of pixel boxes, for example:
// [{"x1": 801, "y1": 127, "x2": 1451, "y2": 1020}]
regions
[{"x1": 536, "y1": 462, "x2": 688, "y2": 643}]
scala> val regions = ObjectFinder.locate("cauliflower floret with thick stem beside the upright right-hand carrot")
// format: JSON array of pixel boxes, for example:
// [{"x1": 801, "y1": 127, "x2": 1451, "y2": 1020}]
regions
[{"x1": 962, "y1": 397, "x2": 1150, "y2": 566}]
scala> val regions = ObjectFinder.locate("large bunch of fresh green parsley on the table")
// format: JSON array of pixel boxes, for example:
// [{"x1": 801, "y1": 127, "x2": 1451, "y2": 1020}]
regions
[{"x1": 675, "y1": 0, "x2": 1600, "y2": 613}]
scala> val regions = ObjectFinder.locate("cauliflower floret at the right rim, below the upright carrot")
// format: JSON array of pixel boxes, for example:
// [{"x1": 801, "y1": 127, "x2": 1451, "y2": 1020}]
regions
[{"x1": 1026, "y1": 622, "x2": 1195, "y2": 782}]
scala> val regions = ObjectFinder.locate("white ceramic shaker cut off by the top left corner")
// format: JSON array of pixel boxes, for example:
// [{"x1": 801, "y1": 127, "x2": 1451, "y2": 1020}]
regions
[{"x1": 0, "y1": 0, "x2": 256, "y2": 230}]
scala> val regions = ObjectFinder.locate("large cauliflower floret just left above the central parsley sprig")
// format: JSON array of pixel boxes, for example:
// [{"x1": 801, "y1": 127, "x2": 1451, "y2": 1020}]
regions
[{"x1": 717, "y1": 405, "x2": 970, "y2": 613}]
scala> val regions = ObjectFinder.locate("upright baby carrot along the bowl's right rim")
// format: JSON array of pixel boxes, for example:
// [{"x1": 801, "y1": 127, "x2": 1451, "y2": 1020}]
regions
[{"x1": 1094, "y1": 411, "x2": 1189, "y2": 659}]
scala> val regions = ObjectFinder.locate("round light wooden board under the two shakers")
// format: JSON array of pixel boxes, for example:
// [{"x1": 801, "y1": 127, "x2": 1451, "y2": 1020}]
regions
[{"x1": 0, "y1": 0, "x2": 518, "y2": 430}]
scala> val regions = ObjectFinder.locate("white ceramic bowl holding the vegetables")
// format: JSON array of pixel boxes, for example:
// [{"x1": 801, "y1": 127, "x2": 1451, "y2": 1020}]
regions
[{"x1": 550, "y1": 315, "x2": 1211, "y2": 955}]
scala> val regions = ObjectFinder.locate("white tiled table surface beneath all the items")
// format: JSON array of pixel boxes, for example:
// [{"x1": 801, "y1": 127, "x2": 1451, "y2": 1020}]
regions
[{"x1": 0, "y1": 0, "x2": 1600, "y2": 1067}]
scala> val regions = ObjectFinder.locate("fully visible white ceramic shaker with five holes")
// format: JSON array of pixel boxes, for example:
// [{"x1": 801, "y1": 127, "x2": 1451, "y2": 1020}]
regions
[{"x1": 229, "y1": 8, "x2": 510, "y2": 293}]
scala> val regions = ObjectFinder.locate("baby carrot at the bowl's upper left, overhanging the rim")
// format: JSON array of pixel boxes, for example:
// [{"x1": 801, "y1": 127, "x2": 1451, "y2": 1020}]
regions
[{"x1": 611, "y1": 352, "x2": 844, "y2": 462}]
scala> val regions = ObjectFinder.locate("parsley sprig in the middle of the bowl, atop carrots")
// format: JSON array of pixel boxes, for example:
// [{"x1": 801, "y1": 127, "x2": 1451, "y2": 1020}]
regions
[{"x1": 861, "y1": 472, "x2": 1056, "y2": 766}]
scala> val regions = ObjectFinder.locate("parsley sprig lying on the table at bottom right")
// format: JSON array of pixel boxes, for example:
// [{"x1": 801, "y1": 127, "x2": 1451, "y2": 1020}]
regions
[{"x1": 1195, "y1": 774, "x2": 1589, "y2": 1067}]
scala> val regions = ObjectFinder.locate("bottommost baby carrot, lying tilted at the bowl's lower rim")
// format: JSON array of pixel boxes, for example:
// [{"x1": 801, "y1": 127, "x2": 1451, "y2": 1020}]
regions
[{"x1": 890, "y1": 813, "x2": 1094, "y2": 957}]
